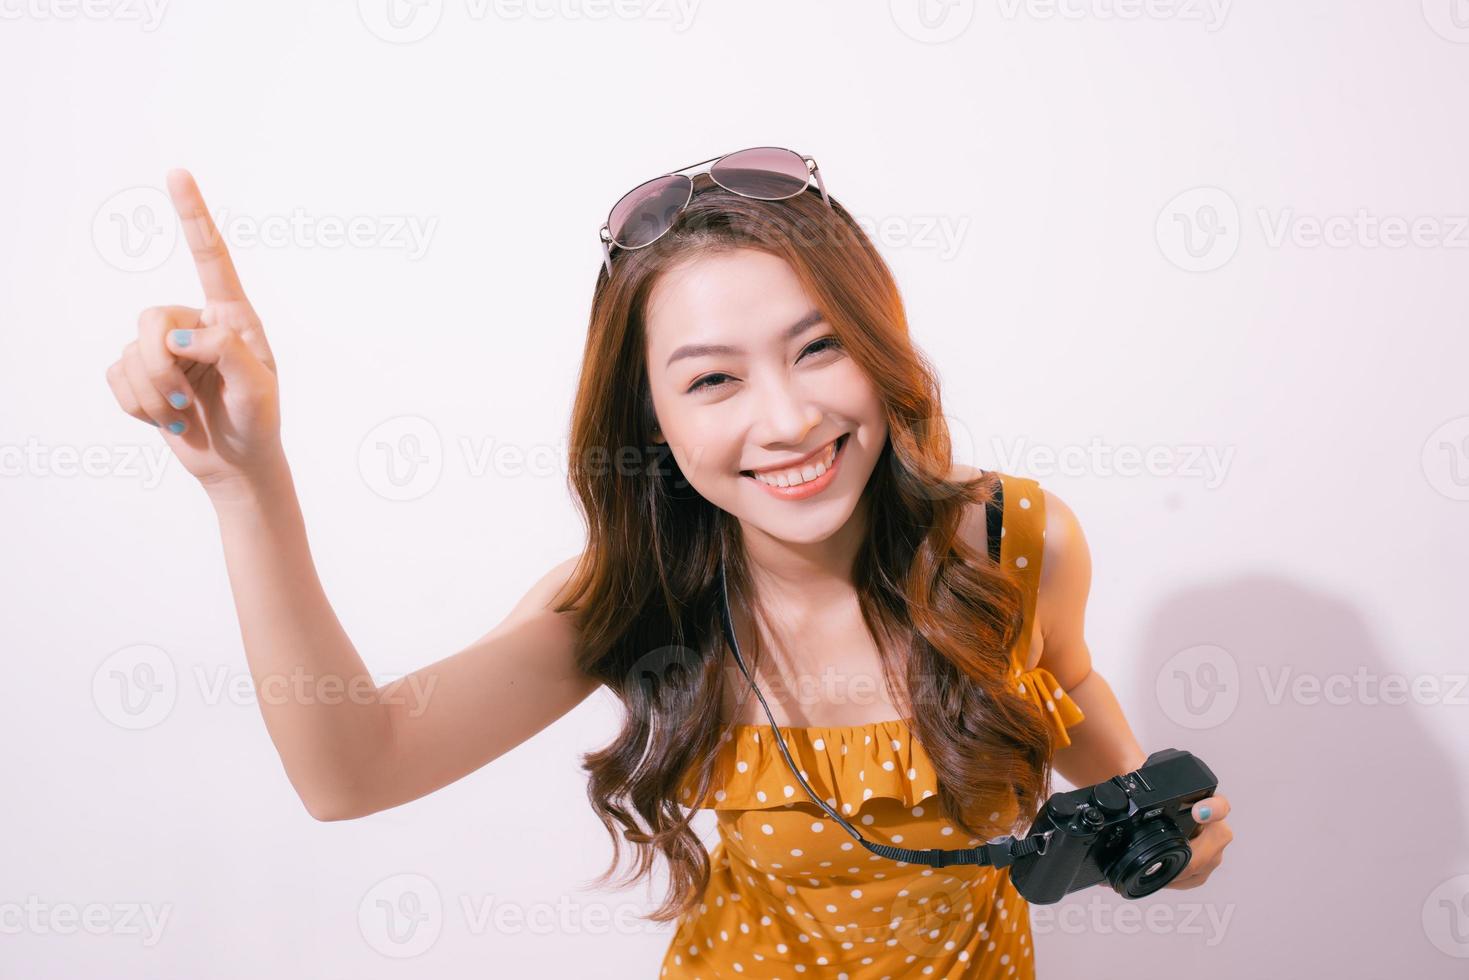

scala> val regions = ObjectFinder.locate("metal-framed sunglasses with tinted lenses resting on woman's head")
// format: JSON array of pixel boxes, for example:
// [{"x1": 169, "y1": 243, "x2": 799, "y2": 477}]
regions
[{"x1": 598, "y1": 147, "x2": 831, "y2": 275}]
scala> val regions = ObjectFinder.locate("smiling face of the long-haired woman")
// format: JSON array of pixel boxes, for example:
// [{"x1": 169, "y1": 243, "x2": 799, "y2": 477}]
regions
[{"x1": 645, "y1": 248, "x2": 887, "y2": 544}]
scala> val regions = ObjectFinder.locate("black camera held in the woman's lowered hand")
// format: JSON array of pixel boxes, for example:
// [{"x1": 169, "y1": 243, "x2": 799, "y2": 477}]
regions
[{"x1": 1011, "y1": 748, "x2": 1219, "y2": 905}]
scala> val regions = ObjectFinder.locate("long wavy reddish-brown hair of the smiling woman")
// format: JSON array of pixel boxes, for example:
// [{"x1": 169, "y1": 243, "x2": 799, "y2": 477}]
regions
[{"x1": 557, "y1": 174, "x2": 1055, "y2": 921}]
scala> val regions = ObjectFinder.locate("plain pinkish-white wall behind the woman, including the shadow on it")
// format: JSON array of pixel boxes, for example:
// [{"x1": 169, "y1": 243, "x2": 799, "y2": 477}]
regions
[{"x1": 0, "y1": 0, "x2": 1469, "y2": 980}]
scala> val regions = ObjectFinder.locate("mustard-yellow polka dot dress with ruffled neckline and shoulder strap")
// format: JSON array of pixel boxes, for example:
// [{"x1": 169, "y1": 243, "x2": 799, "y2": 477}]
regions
[{"x1": 661, "y1": 475, "x2": 1083, "y2": 980}]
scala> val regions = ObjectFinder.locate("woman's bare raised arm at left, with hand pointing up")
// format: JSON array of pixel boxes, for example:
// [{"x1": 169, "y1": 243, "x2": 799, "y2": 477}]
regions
[{"x1": 107, "y1": 170, "x2": 598, "y2": 820}]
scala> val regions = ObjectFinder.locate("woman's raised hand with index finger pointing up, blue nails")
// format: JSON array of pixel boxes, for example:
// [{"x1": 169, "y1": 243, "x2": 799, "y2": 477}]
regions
[{"x1": 107, "y1": 170, "x2": 281, "y2": 489}]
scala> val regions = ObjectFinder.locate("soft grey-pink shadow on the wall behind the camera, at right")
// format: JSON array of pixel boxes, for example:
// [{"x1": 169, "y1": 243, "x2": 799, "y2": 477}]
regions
[{"x1": 1030, "y1": 576, "x2": 1469, "y2": 980}]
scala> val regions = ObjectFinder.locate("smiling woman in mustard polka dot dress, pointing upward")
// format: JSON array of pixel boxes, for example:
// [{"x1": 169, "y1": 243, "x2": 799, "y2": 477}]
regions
[{"x1": 107, "y1": 147, "x2": 1232, "y2": 977}]
